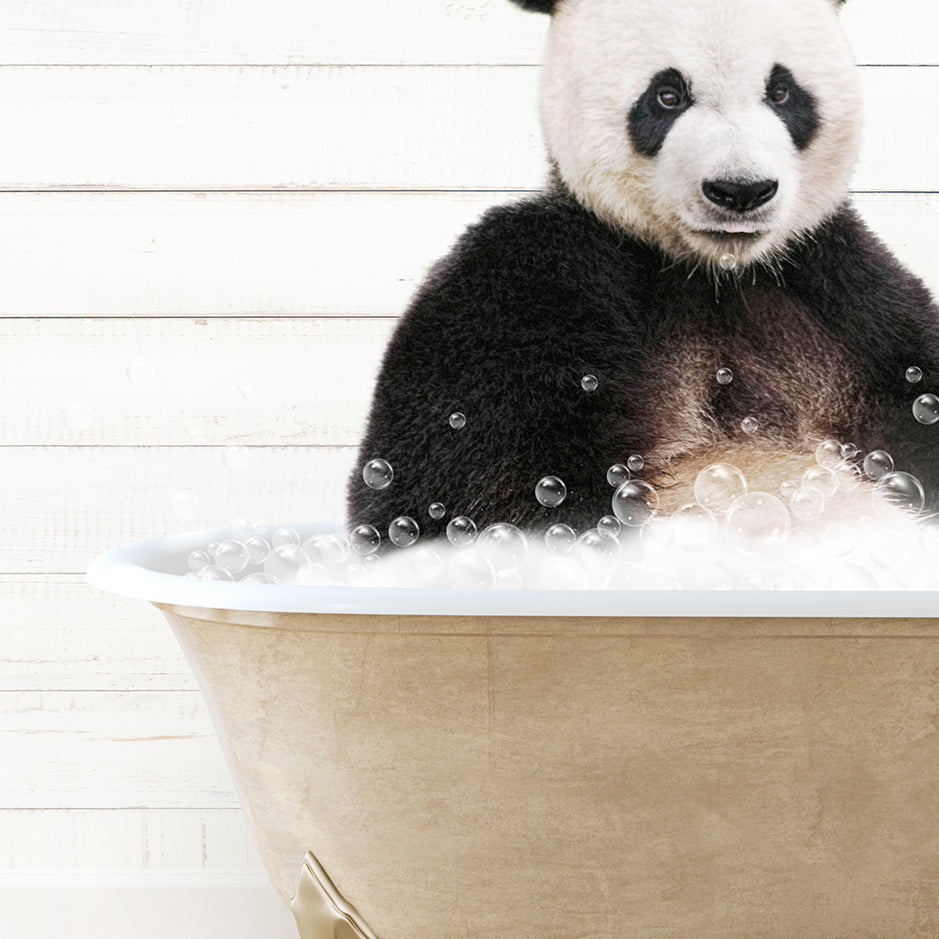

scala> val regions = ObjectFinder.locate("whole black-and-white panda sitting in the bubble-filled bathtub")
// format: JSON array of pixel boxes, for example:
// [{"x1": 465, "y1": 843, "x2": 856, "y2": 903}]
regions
[{"x1": 348, "y1": 0, "x2": 939, "y2": 536}]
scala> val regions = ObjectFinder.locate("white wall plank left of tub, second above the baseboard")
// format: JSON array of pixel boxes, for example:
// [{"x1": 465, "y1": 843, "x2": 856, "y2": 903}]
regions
[{"x1": 0, "y1": 691, "x2": 239, "y2": 809}]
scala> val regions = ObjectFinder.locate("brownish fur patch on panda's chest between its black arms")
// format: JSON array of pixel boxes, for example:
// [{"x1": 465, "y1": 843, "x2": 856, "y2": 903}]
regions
[{"x1": 637, "y1": 288, "x2": 870, "y2": 460}]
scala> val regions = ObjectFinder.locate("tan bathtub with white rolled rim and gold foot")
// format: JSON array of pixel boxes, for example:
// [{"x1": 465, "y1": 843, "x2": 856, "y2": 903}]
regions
[{"x1": 89, "y1": 526, "x2": 939, "y2": 939}]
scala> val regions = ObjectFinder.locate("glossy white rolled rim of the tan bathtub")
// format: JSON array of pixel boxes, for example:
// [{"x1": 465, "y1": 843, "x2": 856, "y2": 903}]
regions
[{"x1": 87, "y1": 522, "x2": 939, "y2": 619}]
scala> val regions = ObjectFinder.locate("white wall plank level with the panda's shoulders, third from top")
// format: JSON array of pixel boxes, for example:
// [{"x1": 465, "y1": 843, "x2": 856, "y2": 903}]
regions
[{"x1": 0, "y1": 192, "x2": 939, "y2": 322}]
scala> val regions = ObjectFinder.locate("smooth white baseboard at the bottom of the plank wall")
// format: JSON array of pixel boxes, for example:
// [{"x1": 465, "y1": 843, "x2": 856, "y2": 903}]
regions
[{"x1": 0, "y1": 871, "x2": 297, "y2": 939}]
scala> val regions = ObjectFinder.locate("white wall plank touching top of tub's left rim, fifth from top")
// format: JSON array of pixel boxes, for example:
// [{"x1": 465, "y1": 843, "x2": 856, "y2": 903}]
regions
[{"x1": 0, "y1": 446, "x2": 356, "y2": 574}]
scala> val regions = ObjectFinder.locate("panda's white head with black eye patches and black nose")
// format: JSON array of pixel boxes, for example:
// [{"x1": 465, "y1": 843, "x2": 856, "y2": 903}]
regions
[{"x1": 515, "y1": 0, "x2": 860, "y2": 272}]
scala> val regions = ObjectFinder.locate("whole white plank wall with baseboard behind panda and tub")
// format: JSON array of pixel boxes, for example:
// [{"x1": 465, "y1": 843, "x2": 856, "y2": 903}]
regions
[{"x1": 0, "y1": 0, "x2": 939, "y2": 939}]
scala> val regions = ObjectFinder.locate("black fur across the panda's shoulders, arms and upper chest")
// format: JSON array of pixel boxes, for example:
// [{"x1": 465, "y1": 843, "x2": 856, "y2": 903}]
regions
[{"x1": 348, "y1": 183, "x2": 939, "y2": 535}]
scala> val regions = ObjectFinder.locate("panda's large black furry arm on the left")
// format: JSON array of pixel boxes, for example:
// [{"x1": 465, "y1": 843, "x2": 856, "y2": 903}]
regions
[{"x1": 348, "y1": 195, "x2": 642, "y2": 535}]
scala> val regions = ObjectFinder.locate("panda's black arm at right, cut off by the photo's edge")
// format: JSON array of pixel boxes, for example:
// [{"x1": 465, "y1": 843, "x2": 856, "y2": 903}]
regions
[{"x1": 787, "y1": 207, "x2": 939, "y2": 511}]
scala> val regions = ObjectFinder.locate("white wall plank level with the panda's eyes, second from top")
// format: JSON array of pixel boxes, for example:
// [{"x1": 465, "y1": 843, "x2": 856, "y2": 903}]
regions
[{"x1": 0, "y1": 66, "x2": 939, "y2": 191}]
